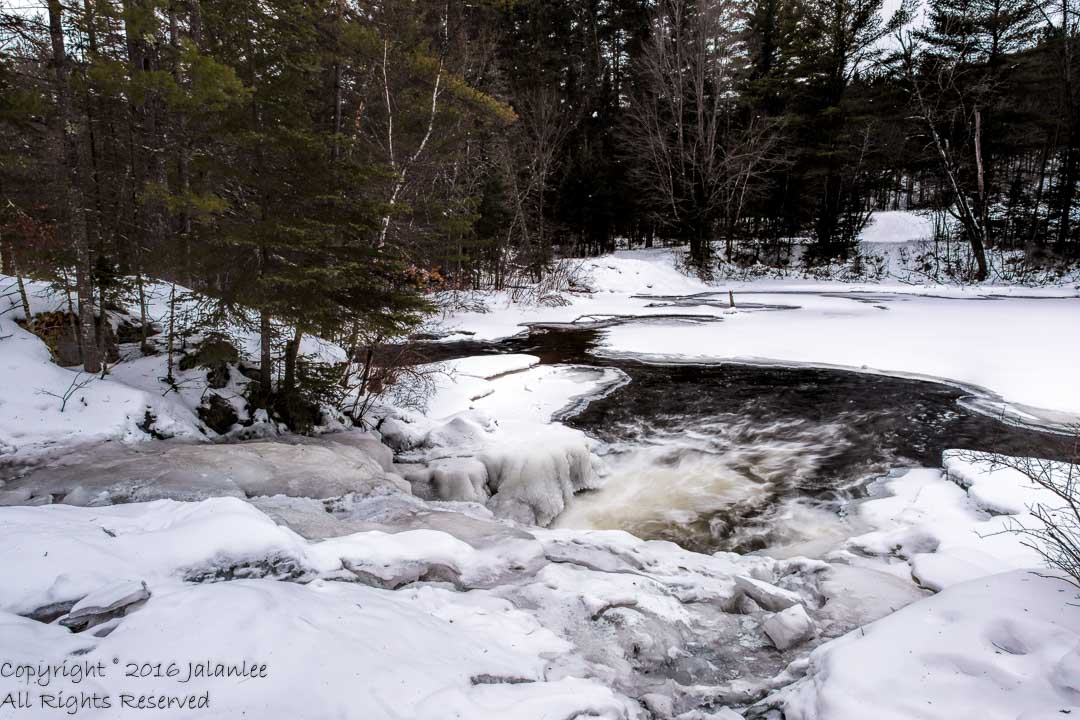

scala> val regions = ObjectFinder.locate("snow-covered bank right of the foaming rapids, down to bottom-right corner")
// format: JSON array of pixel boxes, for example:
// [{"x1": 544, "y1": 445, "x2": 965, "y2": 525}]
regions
[{"x1": 762, "y1": 451, "x2": 1080, "y2": 720}]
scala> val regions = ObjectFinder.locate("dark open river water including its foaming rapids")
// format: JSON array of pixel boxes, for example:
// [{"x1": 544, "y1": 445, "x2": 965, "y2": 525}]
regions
[{"x1": 414, "y1": 320, "x2": 1066, "y2": 555}]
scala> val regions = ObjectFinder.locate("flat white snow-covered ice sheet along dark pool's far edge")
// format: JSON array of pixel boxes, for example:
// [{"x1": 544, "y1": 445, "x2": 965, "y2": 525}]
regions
[{"x1": 602, "y1": 293, "x2": 1080, "y2": 422}]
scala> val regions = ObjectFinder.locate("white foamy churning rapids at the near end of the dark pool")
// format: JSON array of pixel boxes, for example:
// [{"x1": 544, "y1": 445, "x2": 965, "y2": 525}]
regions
[{"x1": 555, "y1": 417, "x2": 872, "y2": 556}]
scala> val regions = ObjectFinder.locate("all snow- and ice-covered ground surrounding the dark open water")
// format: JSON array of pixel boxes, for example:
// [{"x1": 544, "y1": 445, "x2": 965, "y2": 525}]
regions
[{"x1": 0, "y1": 218, "x2": 1080, "y2": 720}]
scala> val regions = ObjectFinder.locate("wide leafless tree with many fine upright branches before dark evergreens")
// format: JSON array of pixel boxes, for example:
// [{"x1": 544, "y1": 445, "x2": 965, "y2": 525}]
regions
[{"x1": 627, "y1": 0, "x2": 774, "y2": 270}]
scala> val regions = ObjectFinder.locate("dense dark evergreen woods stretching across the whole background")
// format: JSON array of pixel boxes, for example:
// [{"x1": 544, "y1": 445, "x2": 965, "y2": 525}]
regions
[{"x1": 0, "y1": 0, "x2": 1080, "y2": 410}]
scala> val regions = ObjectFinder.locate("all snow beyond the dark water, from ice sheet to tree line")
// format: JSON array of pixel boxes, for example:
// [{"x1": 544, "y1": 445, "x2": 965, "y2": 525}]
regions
[{"x1": 432, "y1": 234, "x2": 1080, "y2": 426}]
